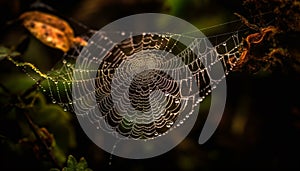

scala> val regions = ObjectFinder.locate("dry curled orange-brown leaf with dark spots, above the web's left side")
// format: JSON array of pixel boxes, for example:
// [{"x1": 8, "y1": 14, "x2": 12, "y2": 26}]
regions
[{"x1": 20, "y1": 11, "x2": 87, "y2": 52}]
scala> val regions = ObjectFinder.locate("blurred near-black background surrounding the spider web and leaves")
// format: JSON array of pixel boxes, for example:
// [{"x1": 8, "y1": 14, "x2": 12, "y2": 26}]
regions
[{"x1": 0, "y1": 0, "x2": 300, "y2": 170}]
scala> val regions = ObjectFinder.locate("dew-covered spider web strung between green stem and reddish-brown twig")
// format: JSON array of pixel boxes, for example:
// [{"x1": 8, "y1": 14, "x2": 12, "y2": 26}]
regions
[{"x1": 16, "y1": 16, "x2": 242, "y2": 142}]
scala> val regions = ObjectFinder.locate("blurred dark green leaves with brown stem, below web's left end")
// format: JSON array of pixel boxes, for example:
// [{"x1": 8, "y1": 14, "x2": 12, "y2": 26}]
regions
[{"x1": 0, "y1": 69, "x2": 76, "y2": 165}]
